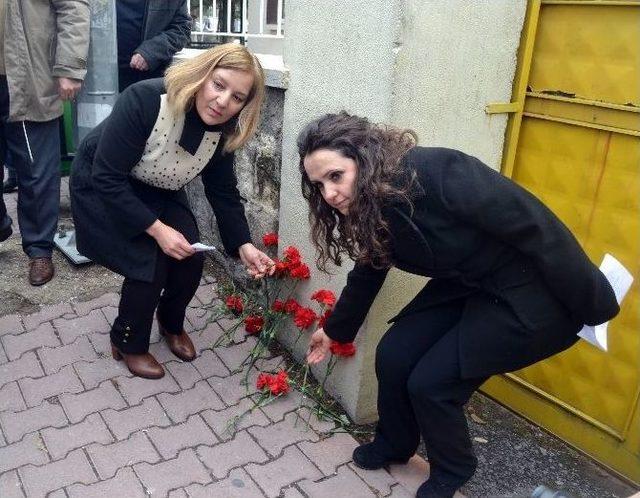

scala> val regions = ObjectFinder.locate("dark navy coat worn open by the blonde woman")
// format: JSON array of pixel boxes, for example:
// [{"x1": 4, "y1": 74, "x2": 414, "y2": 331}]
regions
[{"x1": 70, "y1": 79, "x2": 251, "y2": 282}]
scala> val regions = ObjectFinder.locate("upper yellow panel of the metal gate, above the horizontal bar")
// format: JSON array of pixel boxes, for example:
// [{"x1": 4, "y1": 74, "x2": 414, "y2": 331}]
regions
[{"x1": 529, "y1": 2, "x2": 640, "y2": 104}]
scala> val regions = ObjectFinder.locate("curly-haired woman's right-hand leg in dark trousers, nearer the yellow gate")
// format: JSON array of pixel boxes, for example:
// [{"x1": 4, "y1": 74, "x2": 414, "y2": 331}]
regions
[{"x1": 407, "y1": 326, "x2": 487, "y2": 497}]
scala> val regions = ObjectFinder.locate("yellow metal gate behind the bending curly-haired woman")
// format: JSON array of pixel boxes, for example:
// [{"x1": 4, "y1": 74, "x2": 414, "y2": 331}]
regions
[{"x1": 483, "y1": 0, "x2": 640, "y2": 483}]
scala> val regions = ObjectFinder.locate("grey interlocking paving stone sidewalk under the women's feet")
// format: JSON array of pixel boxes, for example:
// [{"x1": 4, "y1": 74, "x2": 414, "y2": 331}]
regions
[{"x1": 0, "y1": 281, "x2": 460, "y2": 498}]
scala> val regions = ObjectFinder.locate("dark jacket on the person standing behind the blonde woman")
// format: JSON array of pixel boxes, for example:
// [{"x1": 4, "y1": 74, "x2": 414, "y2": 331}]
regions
[{"x1": 134, "y1": 0, "x2": 191, "y2": 71}]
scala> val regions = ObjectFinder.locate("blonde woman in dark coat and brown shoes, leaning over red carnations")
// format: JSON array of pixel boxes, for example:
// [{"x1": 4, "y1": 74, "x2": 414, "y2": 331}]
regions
[{"x1": 70, "y1": 44, "x2": 273, "y2": 379}]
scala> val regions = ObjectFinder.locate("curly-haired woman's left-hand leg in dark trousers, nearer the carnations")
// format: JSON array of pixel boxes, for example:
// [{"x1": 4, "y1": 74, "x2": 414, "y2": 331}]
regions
[{"x1": 354, "y1": 301, "x2": 464, "y2": 468}]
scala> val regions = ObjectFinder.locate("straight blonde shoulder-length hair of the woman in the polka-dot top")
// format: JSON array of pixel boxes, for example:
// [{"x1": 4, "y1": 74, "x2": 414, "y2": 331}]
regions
[{"x1": 164, "y1": 43, "x2": 265, "y2": 152}]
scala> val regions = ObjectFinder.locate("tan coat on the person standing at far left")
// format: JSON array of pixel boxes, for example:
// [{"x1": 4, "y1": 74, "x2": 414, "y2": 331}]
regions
[{"x1": 4, "y1": 0, "x2": 90, "y2": 121}]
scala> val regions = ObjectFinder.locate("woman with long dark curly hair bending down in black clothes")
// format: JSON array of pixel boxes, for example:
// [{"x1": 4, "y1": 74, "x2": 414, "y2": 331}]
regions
[{"x1": 298, "y1": 112, "x2": 619, "y2": 498}]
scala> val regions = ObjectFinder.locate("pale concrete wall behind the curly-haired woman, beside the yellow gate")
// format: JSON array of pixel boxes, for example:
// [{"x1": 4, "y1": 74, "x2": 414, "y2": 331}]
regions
[{"x1": 280, "y1": 0, "x2": 526, "y2": 422}]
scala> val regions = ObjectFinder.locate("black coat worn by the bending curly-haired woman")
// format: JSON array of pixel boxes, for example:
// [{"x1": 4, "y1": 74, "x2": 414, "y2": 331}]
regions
[{"x1": 325, "y1": 147, "x2": 619, "y2": 376}]
